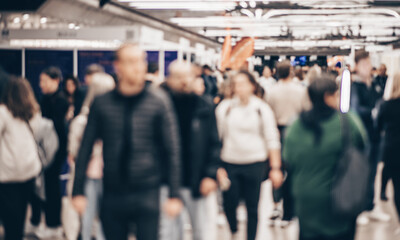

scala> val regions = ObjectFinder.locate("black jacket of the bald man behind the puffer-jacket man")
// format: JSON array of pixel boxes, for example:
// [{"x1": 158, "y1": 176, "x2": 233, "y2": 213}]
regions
[{"x1": 161, "y1": 84, "x2": 221, "y2": 198}]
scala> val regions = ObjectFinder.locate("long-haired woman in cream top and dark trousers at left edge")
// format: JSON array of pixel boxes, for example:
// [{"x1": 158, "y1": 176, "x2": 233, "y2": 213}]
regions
[{"x1": 0, "y1": 78, "x2": 41, "y2": 240}]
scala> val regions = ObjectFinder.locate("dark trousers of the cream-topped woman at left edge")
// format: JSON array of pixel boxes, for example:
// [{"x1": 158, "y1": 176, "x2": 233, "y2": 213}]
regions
[{"x1": 0, "y1": 181, "x2": 33, "y2": 240}]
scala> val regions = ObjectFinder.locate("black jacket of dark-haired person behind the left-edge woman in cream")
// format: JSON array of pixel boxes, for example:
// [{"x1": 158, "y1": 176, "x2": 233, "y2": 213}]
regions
[{"x1": 40, "y1": 89, "x2": 69, "y2": 167}]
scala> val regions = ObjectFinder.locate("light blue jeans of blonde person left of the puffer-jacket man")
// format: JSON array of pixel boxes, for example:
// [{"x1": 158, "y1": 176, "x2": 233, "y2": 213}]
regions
[{"x1": 82, "y1": 178, "x2": 105, "y2": 240}]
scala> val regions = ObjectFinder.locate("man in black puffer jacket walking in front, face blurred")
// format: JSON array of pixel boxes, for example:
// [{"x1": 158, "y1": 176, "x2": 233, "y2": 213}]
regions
[{"x1": 73, "y1": 44, "x2": 182, "y2": 240}]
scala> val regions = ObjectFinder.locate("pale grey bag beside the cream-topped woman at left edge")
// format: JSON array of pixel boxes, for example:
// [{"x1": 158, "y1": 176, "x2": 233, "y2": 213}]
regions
[{"x1": 27, "y1": 117, "x2": 58, "y2": 201}]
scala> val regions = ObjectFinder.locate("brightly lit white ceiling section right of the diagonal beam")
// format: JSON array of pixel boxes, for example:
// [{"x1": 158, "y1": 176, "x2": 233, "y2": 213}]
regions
[{"x1": 112, "y1": 0, "x2": 400, "y2": 51}]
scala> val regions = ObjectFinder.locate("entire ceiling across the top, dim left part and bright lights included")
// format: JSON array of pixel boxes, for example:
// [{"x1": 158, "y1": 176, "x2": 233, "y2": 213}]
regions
[{"x1": 0, "y1": 0, "x2": 400, "y2": 54}]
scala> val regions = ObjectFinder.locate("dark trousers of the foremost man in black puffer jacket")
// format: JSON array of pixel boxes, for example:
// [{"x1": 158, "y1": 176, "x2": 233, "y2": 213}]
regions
[{"x1": 100, "y1": 188, "x2": 160, "y2": 240}]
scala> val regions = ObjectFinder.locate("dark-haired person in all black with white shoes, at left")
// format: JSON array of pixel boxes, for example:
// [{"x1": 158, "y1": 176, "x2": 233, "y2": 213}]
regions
[{"x1": 26, "y1": 67, "x2": 68, "y2": 239}]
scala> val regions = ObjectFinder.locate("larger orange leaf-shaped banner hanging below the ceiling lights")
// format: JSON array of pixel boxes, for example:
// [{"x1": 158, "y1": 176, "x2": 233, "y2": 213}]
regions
[{"x1": 229, "y1": 37, "x2": 254, "y2": 70}]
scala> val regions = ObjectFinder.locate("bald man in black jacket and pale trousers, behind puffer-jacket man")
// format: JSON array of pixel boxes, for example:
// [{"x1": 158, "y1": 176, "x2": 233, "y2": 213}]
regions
[{"x1": 160, "y1": 61, "x2": 223, "y2": 240}]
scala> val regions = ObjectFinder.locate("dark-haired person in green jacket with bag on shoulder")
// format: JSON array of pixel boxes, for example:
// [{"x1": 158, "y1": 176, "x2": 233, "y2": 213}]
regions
[{"x1": 283, "y1": 75, "x2": 367, "y2": 240}]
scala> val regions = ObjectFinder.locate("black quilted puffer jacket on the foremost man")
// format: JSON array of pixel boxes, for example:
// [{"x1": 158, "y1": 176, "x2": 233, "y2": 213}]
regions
[{"x1": 73, "y1": 87, "x2": 180, "y2": 197}]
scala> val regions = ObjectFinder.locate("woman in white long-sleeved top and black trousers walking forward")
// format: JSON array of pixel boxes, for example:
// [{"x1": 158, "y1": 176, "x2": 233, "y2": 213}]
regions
[{"x1": 216, "y1": 71, "x2": 283, "y2": 240}]
